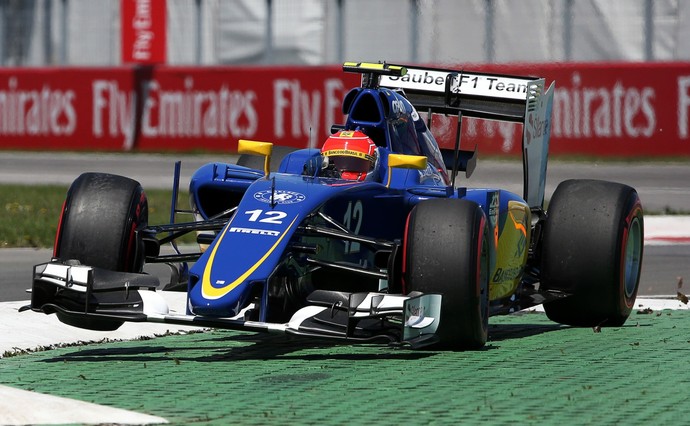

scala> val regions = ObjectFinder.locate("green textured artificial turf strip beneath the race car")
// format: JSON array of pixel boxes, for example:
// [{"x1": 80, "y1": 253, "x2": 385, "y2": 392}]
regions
[{"x1": 0, "y1": 311, "x2": 690, "y2": 425}]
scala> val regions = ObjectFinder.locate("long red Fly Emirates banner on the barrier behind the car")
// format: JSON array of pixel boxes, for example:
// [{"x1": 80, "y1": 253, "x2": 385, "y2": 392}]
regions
[{"x1": 0, "y1": 63, "x2": 690, "y2": 156}]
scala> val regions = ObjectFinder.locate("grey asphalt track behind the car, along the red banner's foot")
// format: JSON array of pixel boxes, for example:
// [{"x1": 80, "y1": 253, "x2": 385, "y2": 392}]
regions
[{"x1": 0, "y1": 152, "x2": 690, "y2": 214}]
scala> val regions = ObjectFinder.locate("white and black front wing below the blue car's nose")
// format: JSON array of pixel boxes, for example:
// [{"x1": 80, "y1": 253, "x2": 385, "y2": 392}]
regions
[{"x1": 27, "y1": 262, "x2": 441, "y2": 348}]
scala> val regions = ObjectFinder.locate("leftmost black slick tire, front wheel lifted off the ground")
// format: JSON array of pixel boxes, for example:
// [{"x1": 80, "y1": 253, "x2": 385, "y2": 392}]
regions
[{"x1": 54, "y1": 173, "x2": 148, "y2": 272}]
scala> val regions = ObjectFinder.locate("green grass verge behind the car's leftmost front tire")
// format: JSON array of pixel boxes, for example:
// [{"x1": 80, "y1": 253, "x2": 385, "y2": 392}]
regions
[{"x1": 0, "y1": 185, "x2": 194, "y2": 248}]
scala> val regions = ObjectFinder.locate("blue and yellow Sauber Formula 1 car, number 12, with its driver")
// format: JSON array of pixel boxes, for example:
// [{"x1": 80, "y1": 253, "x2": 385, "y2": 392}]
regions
[{"x1": 24, "y1": 63, "x2": 643, "y2": 349}]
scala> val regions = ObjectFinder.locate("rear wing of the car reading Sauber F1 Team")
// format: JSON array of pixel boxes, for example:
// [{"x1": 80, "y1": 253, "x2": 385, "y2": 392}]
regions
[{"x1": 343, "y1": 62, "x2": 554, "y2": 208}]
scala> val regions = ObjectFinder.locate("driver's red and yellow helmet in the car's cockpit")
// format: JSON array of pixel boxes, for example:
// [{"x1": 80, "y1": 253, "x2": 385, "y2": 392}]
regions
[{"x1": 321, "y1": 130, "x2": 378, "y2": 181}]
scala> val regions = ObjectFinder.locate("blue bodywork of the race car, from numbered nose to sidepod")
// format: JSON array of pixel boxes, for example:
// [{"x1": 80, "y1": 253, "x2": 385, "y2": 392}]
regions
[{"x1": 181, "y1": 69, "x2": 544, "y2": 321}]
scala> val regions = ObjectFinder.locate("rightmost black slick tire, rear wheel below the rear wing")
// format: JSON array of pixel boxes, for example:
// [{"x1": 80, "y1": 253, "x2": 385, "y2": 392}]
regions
[{"x1": 541, "y1": 180, "x2": 644, "y2": 327}]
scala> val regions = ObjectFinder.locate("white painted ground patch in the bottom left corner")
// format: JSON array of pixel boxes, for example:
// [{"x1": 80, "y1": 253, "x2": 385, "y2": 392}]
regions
[{"x1": 0, "y1": 385, "x2": 168, "y2": 425}]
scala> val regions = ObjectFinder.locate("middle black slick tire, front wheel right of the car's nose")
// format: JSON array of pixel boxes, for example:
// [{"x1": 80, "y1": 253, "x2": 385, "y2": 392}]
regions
[{"x1": 403, "y1": 199, "x2": 489, "y2": 349}]
